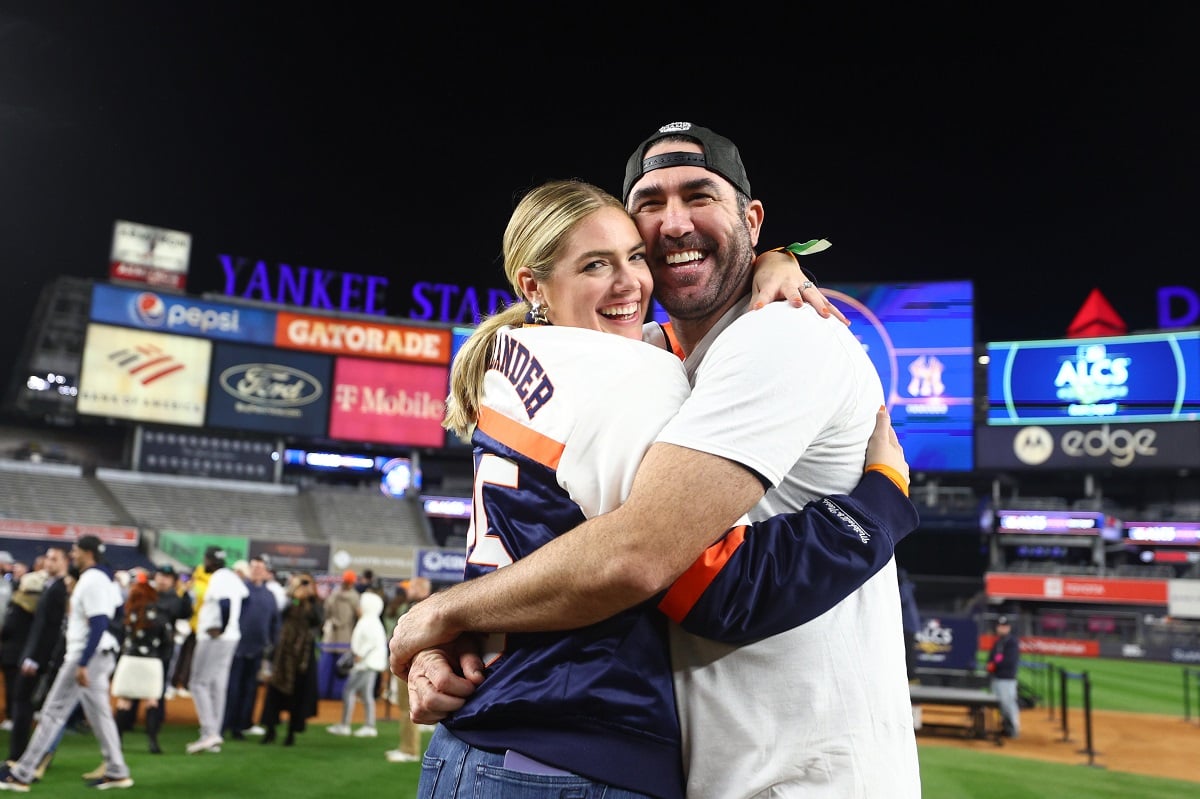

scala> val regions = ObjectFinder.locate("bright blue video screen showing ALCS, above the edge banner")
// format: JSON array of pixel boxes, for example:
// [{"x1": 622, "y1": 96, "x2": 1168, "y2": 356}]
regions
[{"x1": 988, "y1": 331, "x2": 1200, "y2": 426}]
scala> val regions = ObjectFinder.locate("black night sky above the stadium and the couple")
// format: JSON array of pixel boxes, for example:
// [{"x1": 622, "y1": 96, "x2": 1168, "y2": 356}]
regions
[{"x1": 0, "y1": 2, "x2": 1200, "y2": 388}]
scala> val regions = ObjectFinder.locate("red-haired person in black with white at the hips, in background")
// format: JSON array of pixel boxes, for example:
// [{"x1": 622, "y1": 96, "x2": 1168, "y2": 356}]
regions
[{"x1": 116, "y1": 571, "x2": 175, "y2": 755}]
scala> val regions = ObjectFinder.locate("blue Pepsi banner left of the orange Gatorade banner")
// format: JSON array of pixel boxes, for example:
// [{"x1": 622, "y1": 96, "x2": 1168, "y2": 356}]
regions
[{"x1": 91, "y1": 283, "x2": 275, "y2": 344}]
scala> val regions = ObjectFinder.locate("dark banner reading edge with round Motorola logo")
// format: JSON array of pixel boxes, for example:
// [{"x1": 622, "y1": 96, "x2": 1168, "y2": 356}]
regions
[{"x1": 976, "y1": 422, "x2": 1200, "y2": 471}]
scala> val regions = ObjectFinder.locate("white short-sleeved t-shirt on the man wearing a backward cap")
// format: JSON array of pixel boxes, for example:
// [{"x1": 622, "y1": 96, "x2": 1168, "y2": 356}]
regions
[{"x1": 658, "y1": 304, "x2": 920, "y2": 799}]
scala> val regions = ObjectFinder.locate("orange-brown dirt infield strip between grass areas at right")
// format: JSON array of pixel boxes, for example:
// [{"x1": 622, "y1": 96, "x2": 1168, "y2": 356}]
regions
[{"x1": 917, "y1": 708, "x2": 1200, "y2": 782}]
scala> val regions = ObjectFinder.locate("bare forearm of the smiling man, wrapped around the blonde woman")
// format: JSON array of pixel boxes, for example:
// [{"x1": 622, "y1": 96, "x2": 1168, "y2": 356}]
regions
[{"x1": 390, "y1": 444, "x2": 763, "y2": 677}]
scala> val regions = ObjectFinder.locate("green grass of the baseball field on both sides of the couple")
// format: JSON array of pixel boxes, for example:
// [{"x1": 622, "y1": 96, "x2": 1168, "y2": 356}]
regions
[{"x1": 11, "y1": 657, "x2": 1200, "y2": 799}]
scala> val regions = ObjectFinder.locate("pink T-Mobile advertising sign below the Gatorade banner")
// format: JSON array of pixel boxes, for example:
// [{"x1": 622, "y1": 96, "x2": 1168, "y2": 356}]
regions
[{"x1": 329, "y1": 358, "x2": 446, "y2": 446}]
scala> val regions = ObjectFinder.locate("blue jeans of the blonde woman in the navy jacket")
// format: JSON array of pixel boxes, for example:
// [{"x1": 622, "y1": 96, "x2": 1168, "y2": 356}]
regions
[{"x1": 416, "y1": 725, "x2": 667, "y2": 799}]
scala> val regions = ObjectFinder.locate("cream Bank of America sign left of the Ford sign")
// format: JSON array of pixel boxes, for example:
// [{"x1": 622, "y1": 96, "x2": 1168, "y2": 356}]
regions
[{"x1": 76, "y1": 324, "x2": 212, "y2": 427}]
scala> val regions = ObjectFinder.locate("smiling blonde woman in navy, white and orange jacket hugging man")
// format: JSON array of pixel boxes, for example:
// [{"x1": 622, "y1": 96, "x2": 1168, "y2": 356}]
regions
[{"x1": 409, "y1": 181, "x2": 916, "y2": 799}]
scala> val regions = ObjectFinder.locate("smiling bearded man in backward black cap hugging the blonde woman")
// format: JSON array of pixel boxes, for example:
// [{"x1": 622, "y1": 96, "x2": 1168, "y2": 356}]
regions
[{"x1": 392, "y1": 122, "x2": 920, "y2": 799}]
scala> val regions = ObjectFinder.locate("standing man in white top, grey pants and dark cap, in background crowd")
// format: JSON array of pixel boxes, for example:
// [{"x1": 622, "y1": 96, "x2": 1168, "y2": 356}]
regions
[{"x1": 187, "y1": 546, "x2": 248, "y2": 755}]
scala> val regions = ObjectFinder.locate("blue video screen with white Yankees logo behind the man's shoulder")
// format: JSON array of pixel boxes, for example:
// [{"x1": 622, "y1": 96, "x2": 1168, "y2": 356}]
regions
[{"x1": 652, "y1": 281, "x2": 974, "y2": 471}]
